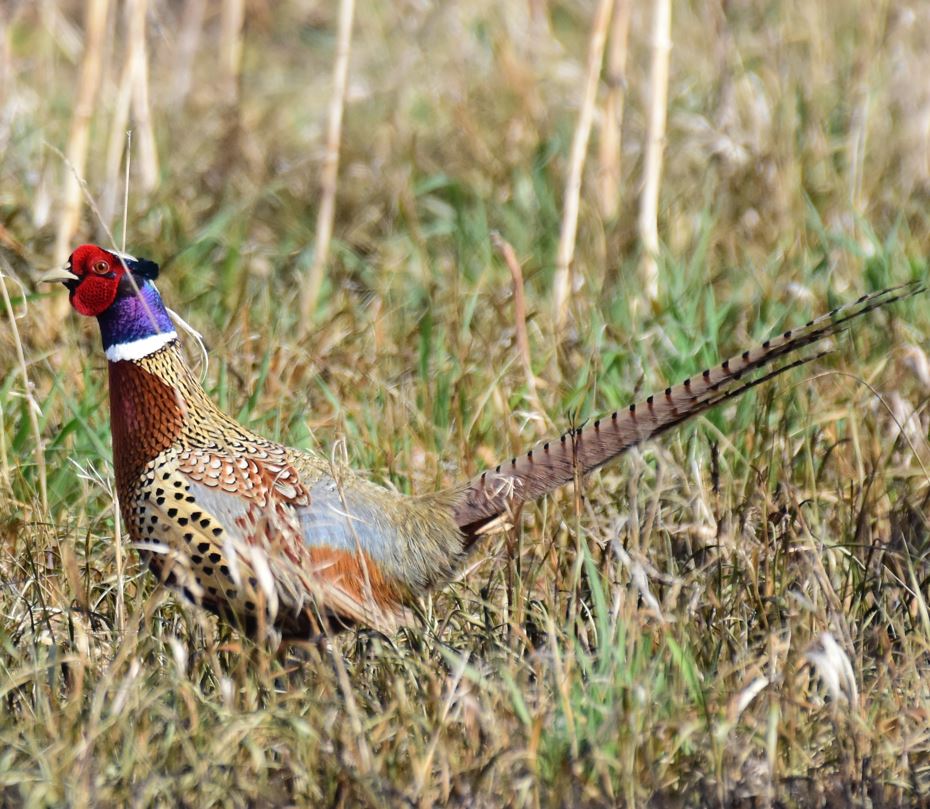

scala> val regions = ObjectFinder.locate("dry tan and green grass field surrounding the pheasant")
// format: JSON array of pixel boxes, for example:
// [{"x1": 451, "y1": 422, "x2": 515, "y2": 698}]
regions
[{"x1": 0, "y1": 0, "x2": 930, "y2": 807}]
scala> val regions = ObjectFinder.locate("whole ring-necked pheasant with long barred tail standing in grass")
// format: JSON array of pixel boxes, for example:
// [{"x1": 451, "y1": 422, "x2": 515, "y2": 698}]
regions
[{"x1": 43, "y1": 245, "x2": 918, "y2": 639}]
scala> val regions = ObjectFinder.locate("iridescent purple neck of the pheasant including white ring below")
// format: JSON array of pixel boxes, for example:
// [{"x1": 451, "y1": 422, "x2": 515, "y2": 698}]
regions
[{"x1": 97, "y1": 281, "x2": 177, "y2": 361}]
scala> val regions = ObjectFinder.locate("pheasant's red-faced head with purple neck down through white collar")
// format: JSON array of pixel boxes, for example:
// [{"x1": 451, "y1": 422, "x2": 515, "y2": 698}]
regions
[{"x1": 42, "y1": 244, "x2": 177, "y2": 362}]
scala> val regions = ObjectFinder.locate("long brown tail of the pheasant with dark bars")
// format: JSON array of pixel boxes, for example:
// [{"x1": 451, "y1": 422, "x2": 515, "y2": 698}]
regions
[{"x1": 453, "y1": 282, "x2": 924, "y2": 537}]
